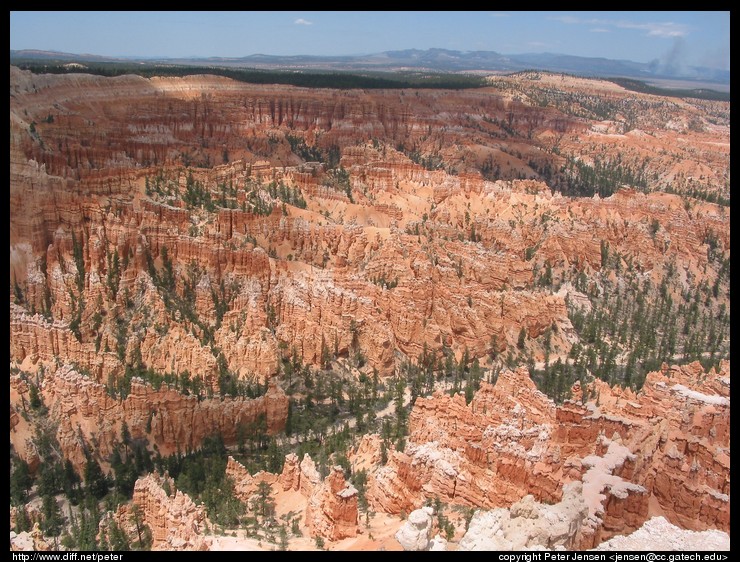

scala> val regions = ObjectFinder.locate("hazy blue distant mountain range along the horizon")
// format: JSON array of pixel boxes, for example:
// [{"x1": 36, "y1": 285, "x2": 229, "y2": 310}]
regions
[{"x1": 10, "y1": 49, "x2": 730, "y2": 85}]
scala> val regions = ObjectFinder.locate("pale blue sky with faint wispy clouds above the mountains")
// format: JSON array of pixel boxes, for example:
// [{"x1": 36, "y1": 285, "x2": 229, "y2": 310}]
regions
[{"x1": 10, "y1": 11, "x2": 730, "y2": 70}]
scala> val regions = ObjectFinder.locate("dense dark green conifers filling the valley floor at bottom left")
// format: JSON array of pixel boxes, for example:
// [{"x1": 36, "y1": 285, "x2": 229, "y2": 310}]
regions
[{"x1": 10, "y1": 374, "x2": 284, "y2": 550}]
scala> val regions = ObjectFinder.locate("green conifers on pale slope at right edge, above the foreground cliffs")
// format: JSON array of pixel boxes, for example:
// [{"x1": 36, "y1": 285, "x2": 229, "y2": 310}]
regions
[{"x1": 534, "y1": 243, "x2": 730, "y2": 401}]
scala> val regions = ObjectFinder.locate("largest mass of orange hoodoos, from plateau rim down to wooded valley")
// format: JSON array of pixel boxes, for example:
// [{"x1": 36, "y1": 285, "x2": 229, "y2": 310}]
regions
[{"x1": 10, "y1": 68, "x2": 729, "y2": 389}]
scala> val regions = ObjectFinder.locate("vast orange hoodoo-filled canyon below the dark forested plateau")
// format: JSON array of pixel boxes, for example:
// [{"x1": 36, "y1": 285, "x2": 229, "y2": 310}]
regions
[{"x1": 9, "y1": 66, "x2": 730, "y2": 550}]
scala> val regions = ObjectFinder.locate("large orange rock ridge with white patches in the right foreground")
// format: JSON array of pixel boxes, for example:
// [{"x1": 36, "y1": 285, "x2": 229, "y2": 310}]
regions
[{"x1": 363, "y1": 362, "x2": 729, "y2": 548}]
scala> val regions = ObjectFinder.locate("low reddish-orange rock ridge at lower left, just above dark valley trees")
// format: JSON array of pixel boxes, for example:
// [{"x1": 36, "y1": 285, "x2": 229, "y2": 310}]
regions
[{"x1": 11, "y1": 366, "x2": 288, "y2": 471}]
